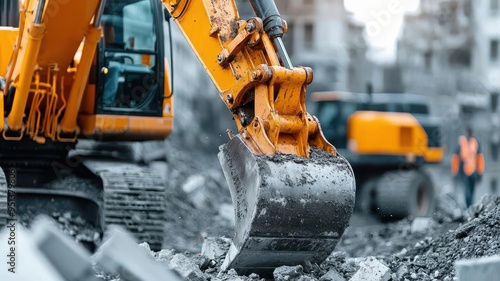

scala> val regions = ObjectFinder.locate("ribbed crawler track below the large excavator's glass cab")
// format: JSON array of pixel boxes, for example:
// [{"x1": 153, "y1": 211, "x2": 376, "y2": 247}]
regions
[{"x1": 84, "y1": 160, "x2": 166, "y2": 250}]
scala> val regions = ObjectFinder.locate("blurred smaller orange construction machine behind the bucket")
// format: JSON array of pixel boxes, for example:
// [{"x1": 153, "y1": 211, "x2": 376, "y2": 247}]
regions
[{"x1": 313, "y1": 92, "x2": 444, "y2": 220}]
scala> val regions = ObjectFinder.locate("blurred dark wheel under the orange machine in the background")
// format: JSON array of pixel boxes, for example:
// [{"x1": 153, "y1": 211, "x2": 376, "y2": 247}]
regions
[{"x1": 375, "y1": 170, "x2": 436, "y2": 220}]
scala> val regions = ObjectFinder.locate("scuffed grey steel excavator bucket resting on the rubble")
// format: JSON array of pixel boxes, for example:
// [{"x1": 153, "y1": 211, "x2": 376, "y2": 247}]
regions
[{"x1": 218, "y1": 135, "x2": 355, "y2": 276}]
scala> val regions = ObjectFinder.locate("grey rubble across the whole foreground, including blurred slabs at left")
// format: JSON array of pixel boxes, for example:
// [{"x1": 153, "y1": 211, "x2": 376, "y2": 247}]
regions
[{"x1": 0, "y1": 192, "x2": 500, "y2": 281}]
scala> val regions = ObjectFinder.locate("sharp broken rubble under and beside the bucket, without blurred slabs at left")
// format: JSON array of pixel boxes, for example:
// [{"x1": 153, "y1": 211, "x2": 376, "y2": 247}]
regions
[{"x1": 123, "y1": 196, "x2": 500, "y2": 281}]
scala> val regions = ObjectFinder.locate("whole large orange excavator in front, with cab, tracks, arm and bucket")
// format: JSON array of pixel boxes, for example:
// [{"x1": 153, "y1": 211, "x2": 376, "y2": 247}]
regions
[{"x1": 0, "y1": 0, "x2": 355, "y2": 274}]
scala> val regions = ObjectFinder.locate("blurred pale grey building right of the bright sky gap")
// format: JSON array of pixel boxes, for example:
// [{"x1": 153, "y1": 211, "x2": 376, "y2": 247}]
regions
[{"x1": 397, "y1": 0, "x2": 500, "y2": 196}]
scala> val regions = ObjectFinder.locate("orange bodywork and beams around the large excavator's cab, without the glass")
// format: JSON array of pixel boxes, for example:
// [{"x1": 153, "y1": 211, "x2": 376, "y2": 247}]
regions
[{"x1": 0, "y1": 0, "x2": 173, "y2": 143}]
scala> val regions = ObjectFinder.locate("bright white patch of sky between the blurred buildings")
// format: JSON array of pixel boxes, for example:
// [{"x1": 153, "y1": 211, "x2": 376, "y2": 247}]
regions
[{"x1": 344, "y1": 0, "x2": 419, "y2": 63}]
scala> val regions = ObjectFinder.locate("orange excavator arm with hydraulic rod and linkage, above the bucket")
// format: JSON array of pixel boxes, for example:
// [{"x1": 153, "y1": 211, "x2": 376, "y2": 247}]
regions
[{"x1": 163, "y1": 0, "x2": 336, "y2": 157}]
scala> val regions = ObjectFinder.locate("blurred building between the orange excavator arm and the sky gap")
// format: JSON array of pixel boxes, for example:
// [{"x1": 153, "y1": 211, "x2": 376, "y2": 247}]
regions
[{"x1": 237, "y1": 0, "x2": 371, "y2": 92}]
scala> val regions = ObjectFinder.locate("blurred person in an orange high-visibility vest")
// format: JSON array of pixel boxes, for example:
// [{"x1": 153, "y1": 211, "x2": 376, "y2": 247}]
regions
[{"x1": 451, "y1": 128, "x2": 484, "y2": 207}]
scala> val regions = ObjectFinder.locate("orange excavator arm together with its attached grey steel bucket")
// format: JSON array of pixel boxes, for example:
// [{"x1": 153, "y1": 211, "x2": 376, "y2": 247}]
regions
[{"x1": 163, "y1": 0, "x2": 355, "y2": 276}]
